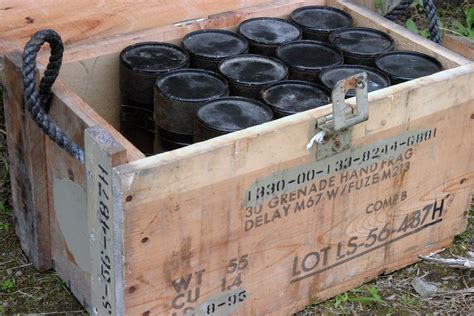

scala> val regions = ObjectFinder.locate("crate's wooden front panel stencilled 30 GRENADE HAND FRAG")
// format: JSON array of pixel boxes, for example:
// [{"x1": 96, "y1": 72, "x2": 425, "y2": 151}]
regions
[{"x1": 115, "y1": 59, "x2": 474, "y2": 315}]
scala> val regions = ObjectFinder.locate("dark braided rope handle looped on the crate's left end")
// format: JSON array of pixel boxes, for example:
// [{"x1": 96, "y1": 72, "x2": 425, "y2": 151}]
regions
[{"x1": 22, "y1": 30, "x2": 85, "y2": 164}]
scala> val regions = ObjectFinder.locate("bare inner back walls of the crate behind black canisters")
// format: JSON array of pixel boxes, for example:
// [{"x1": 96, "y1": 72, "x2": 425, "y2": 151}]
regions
[{"x1": 55, "y1": 1, "x2": 458, "y2": 156}]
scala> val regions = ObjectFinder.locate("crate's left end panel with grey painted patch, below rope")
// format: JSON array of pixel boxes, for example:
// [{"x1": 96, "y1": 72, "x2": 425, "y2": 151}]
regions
[{"x1": 46, "y1": 139, "x2": 91, "y2": 309}]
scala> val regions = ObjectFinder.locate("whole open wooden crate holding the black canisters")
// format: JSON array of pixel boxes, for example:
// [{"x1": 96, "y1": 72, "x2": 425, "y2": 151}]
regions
[{"x1": 2, "y1": 0, "x2": 474, "y2": 315}]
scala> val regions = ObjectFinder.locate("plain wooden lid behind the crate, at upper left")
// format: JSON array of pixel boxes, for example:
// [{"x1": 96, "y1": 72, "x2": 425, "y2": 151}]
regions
[{"x1": 0, "y1": 0, "x2": 272, "y2": 54}]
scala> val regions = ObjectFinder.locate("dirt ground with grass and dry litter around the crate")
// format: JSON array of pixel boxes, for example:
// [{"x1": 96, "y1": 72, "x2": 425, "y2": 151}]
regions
[{"x1": 0, "y1": 0, "x2": 474, "y2": 315}]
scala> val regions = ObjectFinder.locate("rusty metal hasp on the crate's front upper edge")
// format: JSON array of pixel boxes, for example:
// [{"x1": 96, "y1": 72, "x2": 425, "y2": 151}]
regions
[{"x1": 316, "y1": 72, "x2": 369, "y2": 160}]
